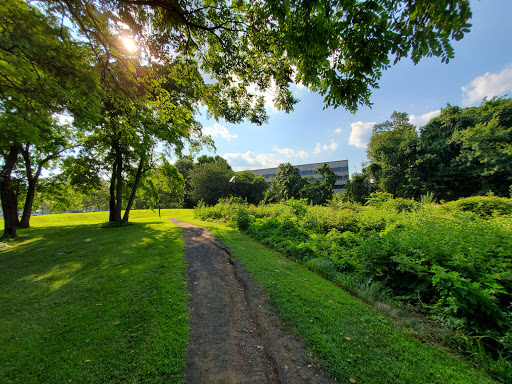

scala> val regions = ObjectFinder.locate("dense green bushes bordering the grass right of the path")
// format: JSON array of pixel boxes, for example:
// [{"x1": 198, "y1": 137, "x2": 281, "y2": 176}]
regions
[{"x1": 196, "y1": 196, "x2": 512, "y2": 358}]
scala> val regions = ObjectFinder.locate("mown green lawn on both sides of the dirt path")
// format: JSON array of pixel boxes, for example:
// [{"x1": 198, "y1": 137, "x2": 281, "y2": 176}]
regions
[{"x1": 0, "y1": 210, "x2": 500, "y2": 384}]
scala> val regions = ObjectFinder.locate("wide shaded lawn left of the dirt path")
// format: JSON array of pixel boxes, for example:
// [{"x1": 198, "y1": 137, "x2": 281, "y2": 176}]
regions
[{"x1": 0, "y1": 211, "x2": 188, "y2": 383}]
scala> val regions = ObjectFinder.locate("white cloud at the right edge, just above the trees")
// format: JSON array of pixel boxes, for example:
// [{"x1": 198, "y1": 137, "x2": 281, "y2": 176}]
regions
[{"x1": 461, "y1": 67, "x2": 512, "y2": 106}]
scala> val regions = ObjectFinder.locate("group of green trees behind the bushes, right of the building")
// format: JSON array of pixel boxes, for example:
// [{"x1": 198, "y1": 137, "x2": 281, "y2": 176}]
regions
[{"x1": 344, "y1": 98, "x2": 512, "y2": 203}]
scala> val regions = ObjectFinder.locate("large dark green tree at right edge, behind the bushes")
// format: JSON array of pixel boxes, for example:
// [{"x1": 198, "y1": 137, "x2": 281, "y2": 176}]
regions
[{"x1": 413, "y1": 99, "x2": 512, "y2": 200}]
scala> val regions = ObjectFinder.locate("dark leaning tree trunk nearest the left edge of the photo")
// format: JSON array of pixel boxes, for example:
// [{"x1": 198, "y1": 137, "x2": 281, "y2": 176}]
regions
[{"x1": 0, "y1": 144, "x2": 20, "y2": 238}]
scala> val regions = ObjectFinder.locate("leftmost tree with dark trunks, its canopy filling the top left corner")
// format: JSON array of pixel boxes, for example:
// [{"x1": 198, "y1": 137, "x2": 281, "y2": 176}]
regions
[{"x1": 0, "y1": 0, "x2": 102, "y2": 237}]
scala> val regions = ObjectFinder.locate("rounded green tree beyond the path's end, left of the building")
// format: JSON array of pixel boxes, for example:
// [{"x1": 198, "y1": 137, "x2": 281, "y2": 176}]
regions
[{"x1": 190, "y1": 162, "x2": 234, "y2": 205}]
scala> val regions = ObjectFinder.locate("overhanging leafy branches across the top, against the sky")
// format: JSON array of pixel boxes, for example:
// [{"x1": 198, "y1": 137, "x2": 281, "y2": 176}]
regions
[{"x1": 48, "y1": 0, "x2": 471, "y2": 112}]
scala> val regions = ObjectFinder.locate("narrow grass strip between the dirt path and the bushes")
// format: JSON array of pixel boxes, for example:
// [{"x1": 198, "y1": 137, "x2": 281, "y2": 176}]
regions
[{"x1": 180, "y1": 211, "x2": 500, "y2": 384}]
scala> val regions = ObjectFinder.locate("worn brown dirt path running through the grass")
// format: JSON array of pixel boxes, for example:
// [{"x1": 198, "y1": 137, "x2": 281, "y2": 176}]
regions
[{"x1": 171, "y1": 218, "x2": 334, "y2": 384}]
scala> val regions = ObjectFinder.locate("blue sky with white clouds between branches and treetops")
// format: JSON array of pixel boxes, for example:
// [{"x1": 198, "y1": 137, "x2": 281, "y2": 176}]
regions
[{"x1": 188, "y1": 0, "x2": 512, "y2": 174}]
